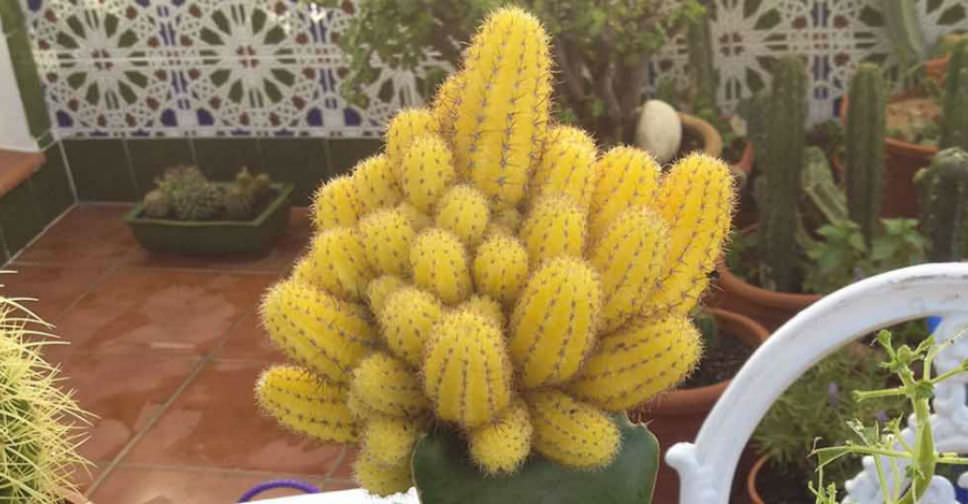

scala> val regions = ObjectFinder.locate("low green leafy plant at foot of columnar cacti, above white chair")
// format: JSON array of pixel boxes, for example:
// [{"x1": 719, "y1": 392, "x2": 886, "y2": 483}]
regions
[{"x1": 803, "y1": 219, "x2": 928, "y2": 294}]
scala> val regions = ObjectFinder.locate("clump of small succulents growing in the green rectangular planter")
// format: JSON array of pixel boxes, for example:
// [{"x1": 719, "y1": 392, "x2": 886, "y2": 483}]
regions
[{"x1": 144, "y1": 166, "x2": 271, "y2": 221}]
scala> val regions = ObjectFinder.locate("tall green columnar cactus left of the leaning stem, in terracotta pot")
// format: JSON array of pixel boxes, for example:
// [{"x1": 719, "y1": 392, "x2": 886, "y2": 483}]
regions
[{"x1": 760, "y1": 56, "x2": 807, "y2": 291}]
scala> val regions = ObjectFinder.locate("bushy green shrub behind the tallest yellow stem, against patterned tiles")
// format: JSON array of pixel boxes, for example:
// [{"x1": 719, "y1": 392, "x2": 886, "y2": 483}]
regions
[{"x1": 312, "y1": 0, "x2": 703, "y2": 144}]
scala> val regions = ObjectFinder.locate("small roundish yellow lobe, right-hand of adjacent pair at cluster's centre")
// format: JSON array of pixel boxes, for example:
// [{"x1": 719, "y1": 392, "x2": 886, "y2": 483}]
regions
[{"x1": 474, "y1": 234, "x2": 528, "y2": 303}]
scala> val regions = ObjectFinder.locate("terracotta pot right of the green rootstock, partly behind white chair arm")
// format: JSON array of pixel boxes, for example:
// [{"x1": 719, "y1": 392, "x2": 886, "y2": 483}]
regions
[{"x1": 633, "y1": 309, "x2": 770, "y2": 503}]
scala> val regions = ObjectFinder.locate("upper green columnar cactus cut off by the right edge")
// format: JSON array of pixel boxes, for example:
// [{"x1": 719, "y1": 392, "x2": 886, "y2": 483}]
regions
[{"x1": 939, "y1": 38, "x2": 968, "y2": 151}]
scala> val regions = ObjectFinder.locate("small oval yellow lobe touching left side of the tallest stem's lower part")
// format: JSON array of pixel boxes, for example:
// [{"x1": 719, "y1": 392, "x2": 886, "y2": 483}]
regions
[{"x1": 400, "y1": 136, "x2": 456, "y2": 213}]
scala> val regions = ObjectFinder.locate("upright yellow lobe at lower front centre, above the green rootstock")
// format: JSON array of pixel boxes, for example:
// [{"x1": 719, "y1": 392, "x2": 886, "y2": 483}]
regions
[{"x1": 423, "y1": 311, "x2": 511, "y2": 427}]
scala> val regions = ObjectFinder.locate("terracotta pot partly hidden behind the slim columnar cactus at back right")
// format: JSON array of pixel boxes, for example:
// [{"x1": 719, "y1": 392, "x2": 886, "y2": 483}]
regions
[{"x1": 840, "y1": 94, "x2": 938, "y2": 218}]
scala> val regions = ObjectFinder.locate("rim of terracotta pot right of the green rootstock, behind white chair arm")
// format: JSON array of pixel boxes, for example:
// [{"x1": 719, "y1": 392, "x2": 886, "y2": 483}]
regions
[{"x1": 644, "y1": 307, "x2": 770, "y2": 416}]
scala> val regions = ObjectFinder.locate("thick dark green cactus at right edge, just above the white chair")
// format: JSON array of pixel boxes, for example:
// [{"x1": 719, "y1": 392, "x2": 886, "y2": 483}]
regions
[{"x1": 915, "y1": 147, "x2": 968, "y2": 262}]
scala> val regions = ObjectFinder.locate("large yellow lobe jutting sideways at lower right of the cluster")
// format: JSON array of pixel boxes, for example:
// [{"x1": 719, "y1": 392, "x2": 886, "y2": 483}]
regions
[{"x1": 568, "y1": 315, "x2": 702, "y2": 411}]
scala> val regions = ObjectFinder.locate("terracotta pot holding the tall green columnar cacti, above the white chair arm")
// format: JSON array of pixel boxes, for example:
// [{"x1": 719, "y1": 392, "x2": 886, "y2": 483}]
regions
[{"x1": 712, "y1": 264, "x2": 821, "y2": 332}]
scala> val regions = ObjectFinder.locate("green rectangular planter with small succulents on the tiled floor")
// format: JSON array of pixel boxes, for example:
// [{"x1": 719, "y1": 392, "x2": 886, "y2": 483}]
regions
[{"x1": 125, "y1": 166, "x2": 293, "y2": 255}]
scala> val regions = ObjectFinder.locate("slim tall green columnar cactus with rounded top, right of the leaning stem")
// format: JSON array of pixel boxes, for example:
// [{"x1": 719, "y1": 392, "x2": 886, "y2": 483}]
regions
[{"x1": 846, "y1": 63, "x2": 887, "y2": 246}]
